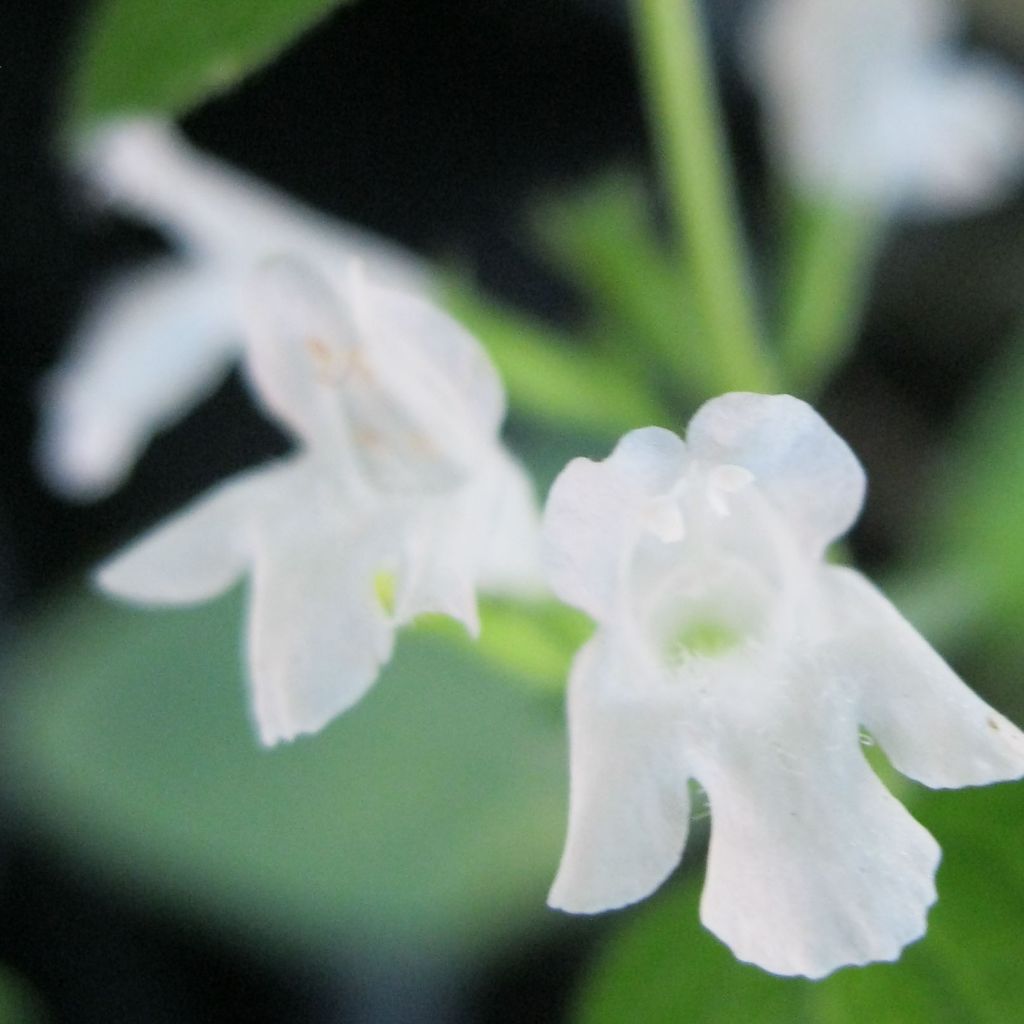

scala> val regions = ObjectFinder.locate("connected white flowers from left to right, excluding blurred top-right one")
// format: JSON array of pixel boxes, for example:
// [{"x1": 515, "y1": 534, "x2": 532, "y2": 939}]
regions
[{"x1": 42, "y1": 116, "x2": 1024, "y2": 977}]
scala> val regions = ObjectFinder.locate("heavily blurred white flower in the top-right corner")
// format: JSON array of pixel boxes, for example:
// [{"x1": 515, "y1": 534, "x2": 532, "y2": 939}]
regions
[{"x1": 748, "y1": 0, "x2": 1024, "y2": 213}]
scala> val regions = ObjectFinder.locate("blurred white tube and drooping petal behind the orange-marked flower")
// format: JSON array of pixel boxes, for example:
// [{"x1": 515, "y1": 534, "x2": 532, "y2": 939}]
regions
[{"x1": 38, "y1": 120, "x2": 426, "y2": 500}]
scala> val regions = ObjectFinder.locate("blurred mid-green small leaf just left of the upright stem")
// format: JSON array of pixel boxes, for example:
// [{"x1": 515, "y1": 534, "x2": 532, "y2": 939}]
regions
[{"x1": 534, "y1": 171, "x2": 712, "y2": 397}]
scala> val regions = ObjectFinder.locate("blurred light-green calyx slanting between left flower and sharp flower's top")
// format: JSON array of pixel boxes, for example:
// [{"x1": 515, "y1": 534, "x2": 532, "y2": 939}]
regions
[{"x1": 444, "y1": 282, "x2": 671, "y2": 436}]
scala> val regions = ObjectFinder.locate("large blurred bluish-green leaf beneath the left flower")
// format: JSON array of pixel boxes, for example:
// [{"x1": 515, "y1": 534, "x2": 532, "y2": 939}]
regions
[{"x1": 3, "y1": 595, "x2": 565, "y2": 957}]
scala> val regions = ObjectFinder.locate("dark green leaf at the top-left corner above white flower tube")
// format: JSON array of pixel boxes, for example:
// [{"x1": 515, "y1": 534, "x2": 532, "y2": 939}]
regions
[{"x1": 68, "y1": 0, "x2": 352, "y2": 136}]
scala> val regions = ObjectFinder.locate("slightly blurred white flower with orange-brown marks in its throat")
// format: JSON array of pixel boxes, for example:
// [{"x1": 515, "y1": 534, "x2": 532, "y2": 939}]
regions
[{"x1": 98, "y1": 260, "x2": 540, "y2": 744}]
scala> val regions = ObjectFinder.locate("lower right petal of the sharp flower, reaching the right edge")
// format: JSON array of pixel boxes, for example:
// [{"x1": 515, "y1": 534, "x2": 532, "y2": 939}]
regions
[{"x1": 822, "y1": 566, "x2": 1024, "y2": 788}]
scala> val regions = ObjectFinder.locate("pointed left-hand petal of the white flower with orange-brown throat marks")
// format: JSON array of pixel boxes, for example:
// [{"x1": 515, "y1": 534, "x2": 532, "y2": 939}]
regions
[{"x1": 95, "y1": 463, "x2": 284, "y2": 604}]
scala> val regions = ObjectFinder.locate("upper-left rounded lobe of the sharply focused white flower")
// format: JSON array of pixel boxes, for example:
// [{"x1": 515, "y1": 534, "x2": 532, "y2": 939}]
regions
[{"x1": 543, "y1": 427, "x2": 686, "y2": 621}]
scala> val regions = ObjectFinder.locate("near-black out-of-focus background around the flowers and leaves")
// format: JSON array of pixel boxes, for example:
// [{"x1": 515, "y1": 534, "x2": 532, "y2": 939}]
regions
[{"x1": 6, "y1": 0, "x2": 1024, "y2": 1024}]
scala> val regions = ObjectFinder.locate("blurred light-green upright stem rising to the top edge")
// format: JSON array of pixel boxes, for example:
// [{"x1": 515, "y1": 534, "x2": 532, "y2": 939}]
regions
[{"x1": 633, "y1": 0, "x2": 775, "y2": 391}]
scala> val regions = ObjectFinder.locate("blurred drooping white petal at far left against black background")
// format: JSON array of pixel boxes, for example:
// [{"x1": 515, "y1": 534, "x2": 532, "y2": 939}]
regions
[{"x1": 38, "y1": 261, "x2": 241, "y2": 500}]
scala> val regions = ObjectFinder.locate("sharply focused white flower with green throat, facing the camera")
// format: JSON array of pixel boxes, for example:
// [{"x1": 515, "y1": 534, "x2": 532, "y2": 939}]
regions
[{"x1": 544, "y1": 393, "x2": 1024, "y2": 978}]
